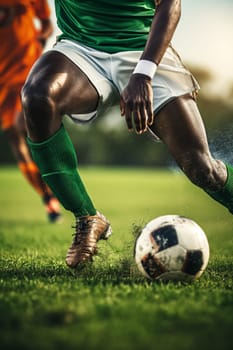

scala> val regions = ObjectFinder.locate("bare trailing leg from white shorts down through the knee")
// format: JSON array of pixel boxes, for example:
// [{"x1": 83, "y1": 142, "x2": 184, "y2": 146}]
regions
[{"x1": 151, "y1": 95, "x2": 227, "y2": 191}]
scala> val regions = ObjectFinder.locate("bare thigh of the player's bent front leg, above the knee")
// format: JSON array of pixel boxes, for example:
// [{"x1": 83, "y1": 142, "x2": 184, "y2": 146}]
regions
[{"x1": 22, "y1": 51, "x2": 99, "y2": 114}]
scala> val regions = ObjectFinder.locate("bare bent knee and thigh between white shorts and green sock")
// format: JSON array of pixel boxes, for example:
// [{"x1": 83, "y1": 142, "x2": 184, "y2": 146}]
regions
[{"x1": 22, "y1": 52, "x2": 99, "y2": 142}]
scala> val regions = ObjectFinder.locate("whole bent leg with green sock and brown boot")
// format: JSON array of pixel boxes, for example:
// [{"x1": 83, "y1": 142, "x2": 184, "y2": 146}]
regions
[{"x1": 22, "y1": 52, "x2": 110, "y2": 267}]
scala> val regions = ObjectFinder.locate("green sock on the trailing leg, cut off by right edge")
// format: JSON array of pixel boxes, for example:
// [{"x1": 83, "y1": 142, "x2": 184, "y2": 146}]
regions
[{"x1": 205, "y1": 164, "x2": 233, "y2": 214}]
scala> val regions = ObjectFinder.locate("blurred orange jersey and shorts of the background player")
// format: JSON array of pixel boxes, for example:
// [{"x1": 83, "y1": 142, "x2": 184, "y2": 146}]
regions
[{"x1": 0, "y1": 0, "x2": 50, "y2": 129}]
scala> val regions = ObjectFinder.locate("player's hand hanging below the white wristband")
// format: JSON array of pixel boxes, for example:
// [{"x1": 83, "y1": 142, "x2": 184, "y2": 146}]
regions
[{"x1": 120, "y1": 74, "x2": 154, "y2": 134}]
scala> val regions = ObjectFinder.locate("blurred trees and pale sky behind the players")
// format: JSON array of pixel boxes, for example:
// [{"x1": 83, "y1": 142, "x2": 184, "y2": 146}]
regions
[{"x1": 0, "y1": 0, "x2": 233, "y2": 167}]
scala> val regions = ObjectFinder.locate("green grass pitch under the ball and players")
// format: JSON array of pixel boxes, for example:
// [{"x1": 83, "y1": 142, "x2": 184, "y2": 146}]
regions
[{"x1": 0, "y1": 167, "x2": 233, "y2": 350}]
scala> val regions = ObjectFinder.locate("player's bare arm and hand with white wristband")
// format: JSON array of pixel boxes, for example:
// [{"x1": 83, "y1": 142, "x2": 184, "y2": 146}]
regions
[{"x1": 120, "y1": 0, "x2": 181, "y2": 133}]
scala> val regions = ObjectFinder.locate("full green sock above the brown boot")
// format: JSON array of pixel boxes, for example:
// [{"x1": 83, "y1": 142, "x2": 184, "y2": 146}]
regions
[{"x1": 27, "y1": 125, "x2": 96, "y2": 217}]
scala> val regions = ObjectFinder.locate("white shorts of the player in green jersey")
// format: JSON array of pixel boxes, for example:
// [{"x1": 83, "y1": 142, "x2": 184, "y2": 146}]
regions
[{"x1": 51, "y1": 40, "x2": 199, "y2": 123}]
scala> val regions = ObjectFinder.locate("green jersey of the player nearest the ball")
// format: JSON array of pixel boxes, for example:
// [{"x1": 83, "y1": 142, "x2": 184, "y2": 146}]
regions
[{"x1": 55, "y1": 0, "x2": 155, "y2": 53}]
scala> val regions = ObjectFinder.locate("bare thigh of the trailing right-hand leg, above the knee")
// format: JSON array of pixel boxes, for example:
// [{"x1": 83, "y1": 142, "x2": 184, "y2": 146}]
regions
[{"x1": 152, "y1": 95, "x2": 210, "y2": 166}]
